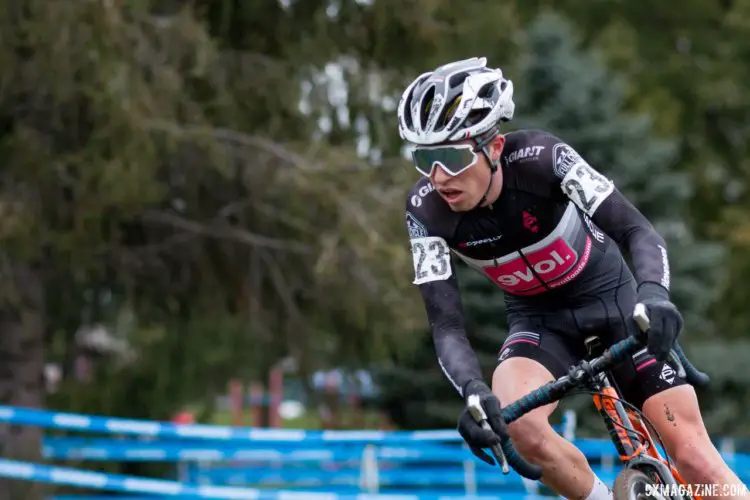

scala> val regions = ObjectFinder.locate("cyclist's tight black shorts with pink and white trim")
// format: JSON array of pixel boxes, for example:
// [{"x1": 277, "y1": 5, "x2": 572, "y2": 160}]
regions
[{"x1": 498, "y1": 281, "x2": 686, "y2": 409}]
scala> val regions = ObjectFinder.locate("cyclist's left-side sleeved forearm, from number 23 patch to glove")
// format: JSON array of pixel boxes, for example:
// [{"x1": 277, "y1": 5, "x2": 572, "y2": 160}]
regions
[{"x1": 420, "y1": 278, "x2": 482, "y2": 396}]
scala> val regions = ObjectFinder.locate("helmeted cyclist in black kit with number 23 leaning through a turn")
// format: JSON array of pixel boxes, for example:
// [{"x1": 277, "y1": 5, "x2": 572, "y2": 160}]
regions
[{"x1": 398, "y1": 58, "x2": 742, "y2": 500}]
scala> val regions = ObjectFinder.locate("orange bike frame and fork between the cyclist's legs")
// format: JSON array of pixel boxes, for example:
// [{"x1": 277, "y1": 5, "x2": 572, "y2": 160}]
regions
[{"x1": 593, "y1": 384, "x2": 702, "y2": 500}]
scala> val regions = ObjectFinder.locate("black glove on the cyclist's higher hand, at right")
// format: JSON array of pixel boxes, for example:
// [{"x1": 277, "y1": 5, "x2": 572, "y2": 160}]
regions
[{"x1": 638, "y1": 283, "x2": 683, "y2": 361}]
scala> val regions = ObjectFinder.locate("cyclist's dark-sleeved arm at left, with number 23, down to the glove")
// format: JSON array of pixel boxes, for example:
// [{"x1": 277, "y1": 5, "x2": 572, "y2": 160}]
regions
[{"x1": 407, "y1": 211, "x2": 482, "y2": 396}]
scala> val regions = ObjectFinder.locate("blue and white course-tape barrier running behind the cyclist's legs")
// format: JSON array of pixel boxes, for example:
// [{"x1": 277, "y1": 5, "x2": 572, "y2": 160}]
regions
[{"x1": 0, "y1": 406, "x2": 750, "y2": 500}]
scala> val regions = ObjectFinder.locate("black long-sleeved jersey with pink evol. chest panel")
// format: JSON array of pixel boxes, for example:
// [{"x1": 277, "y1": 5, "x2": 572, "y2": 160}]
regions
[{"x1": 406, "y1": 130, "x2": 669, "y2": 392}]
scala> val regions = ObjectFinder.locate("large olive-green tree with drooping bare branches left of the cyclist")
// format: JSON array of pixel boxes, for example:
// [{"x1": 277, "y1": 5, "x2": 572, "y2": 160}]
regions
[{"x1": 0, "y1": 0, "x2": 434, "y2": 492}]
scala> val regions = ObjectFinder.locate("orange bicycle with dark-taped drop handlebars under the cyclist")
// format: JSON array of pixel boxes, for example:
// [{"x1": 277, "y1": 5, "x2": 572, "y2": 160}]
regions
[{"x1": 468, "y1": 304, "x2": 709, "y2": 500}]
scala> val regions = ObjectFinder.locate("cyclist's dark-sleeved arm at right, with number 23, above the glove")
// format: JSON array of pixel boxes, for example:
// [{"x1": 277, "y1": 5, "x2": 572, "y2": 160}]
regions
[{"x1": 553, "y1": 143, "x2": 669, "y2": 293}]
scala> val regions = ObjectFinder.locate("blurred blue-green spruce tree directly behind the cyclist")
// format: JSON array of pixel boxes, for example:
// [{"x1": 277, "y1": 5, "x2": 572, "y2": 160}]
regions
[{"x1": 381, "y1": 13, "x2": 721, "y2": 432}]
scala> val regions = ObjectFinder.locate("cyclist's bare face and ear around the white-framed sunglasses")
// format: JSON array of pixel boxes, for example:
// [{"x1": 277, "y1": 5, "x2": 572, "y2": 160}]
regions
[{"x1": 430, "y1": 135, "x2": 505, "y2": 212}]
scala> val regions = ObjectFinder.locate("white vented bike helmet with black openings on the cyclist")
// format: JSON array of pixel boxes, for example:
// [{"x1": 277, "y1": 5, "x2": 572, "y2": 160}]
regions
[{"x1": 398, "y1": 57, "x2": 515, "y2": 145}]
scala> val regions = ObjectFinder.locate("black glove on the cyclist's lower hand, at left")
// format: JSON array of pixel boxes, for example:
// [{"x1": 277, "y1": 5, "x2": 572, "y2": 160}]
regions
[{"x1": 458, "y1": 380, "x2": 509, "y2": 465}]
